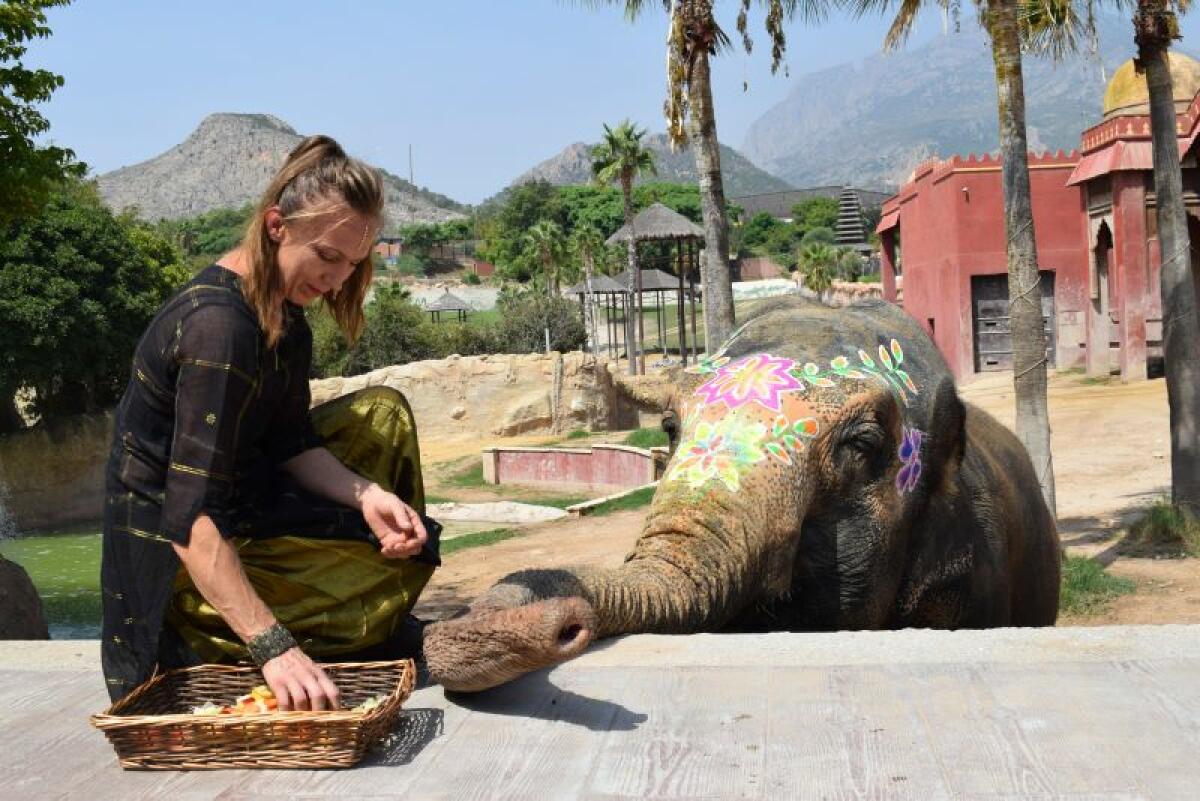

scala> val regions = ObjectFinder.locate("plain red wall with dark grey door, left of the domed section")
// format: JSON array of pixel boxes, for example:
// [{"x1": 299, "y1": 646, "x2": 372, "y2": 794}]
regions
[{"x1": 892, "y1": 152, "x2": 1087, "y2": 377}]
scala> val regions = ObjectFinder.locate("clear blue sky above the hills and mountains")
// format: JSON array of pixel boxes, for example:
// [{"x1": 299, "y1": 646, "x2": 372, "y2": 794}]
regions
[{"x1": 29, "y1": 0, "x2": 1200, "y2": 203}]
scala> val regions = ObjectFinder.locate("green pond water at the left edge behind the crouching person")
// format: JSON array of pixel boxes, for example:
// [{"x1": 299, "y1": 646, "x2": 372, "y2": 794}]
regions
[{"x1": 0, "y1": 529, "x2": 100, "y2": 639}]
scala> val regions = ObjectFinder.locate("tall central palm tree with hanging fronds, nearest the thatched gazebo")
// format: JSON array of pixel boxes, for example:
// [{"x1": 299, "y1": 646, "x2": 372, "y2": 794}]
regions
[{"x1": 581, "y1": 0, "x2": 829, "y2": 345}]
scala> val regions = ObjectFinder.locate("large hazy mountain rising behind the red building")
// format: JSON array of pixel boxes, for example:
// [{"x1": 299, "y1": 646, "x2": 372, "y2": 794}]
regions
[{"x1": 742, "y1": 14, "x2": 1171, "y2": 187}]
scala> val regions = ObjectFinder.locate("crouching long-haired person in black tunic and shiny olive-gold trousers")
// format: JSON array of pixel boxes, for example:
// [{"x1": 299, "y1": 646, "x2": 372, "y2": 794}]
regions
[{"x1": 101, "y1": 137, "x2": 438, "y2": 710}]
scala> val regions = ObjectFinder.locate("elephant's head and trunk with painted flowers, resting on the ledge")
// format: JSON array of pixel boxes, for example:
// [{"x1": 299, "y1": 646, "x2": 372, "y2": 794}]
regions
[{"x1": 425, "y1": 297, "x2": 979, "y2": 689}]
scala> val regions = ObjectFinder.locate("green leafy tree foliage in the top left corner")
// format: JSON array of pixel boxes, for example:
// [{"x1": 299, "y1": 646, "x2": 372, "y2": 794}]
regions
[{"x1": 0, "y1": 0, "x2": 85, "y2": 224}]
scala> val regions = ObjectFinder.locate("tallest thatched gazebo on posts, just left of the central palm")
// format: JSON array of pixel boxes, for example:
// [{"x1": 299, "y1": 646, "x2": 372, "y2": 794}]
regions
[{"x1": 605, "y1": 203, "x2": 704, "y2": 368}]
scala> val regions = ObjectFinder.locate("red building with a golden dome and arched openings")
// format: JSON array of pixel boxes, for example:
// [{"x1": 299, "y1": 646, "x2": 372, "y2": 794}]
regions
[{"x1": 876, "y1": 53, "x2": 1200, "y2": 380}]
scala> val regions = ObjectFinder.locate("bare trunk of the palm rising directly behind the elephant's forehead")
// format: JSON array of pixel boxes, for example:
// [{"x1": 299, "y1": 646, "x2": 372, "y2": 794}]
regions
[{"x1": 688, "y1": 49, "x2": 733, "y2": 353}]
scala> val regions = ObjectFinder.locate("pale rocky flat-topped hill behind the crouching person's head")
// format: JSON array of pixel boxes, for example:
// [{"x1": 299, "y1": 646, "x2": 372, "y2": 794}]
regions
[{"x1": 97, "y1": 114, "x2": 463, "y2": 233}]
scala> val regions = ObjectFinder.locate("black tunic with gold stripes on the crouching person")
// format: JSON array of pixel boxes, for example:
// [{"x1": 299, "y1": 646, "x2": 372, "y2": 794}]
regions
[{"x1": 101, "y1": 265, "x2": 328, "y2": 699}]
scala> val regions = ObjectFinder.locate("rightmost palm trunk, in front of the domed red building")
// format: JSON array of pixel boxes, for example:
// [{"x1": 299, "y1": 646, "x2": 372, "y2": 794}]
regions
[{"x1": 1134, "y1": 6, "x2": 1200, "y2": 514}]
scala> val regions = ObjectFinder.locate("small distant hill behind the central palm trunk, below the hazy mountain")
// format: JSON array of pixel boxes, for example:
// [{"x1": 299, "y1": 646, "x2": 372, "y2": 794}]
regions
[{"x1": 501, "y1": 133, "x2": 792, "y2": 198}]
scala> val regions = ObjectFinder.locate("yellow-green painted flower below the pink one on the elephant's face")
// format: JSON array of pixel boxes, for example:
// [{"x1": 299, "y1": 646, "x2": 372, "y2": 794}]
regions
[{"x1": 667, "y1": 415, "x2": 767, "y2": 492}]
